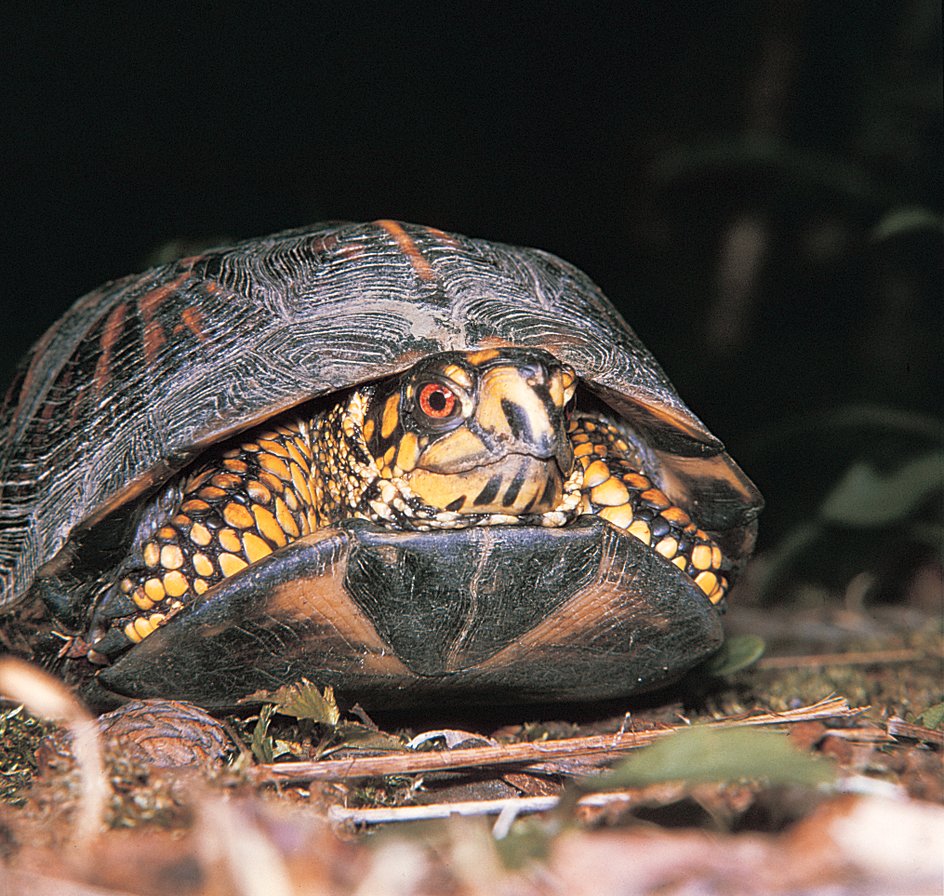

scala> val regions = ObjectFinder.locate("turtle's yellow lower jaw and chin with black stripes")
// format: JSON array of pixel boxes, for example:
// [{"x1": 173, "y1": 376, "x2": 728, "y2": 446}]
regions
[{"x1": 404, "y1": 454, "x2": 566, "y2": 516}]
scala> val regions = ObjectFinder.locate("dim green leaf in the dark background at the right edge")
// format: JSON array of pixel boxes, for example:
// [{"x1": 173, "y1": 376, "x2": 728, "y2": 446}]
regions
[{"x1": 820, "y1": 452, "x2": 944, "y2": 528}]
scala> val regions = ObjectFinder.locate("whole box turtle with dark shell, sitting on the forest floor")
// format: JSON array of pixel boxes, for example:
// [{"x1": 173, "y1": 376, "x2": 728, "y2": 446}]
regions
[{"x1": 0, "y1": 220, "x2": 762, "y2": 709}]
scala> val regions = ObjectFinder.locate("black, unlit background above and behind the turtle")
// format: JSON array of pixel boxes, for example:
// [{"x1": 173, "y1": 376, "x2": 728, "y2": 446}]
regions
[{"x1": 0, "y1": 0, "x2": 944, "y2": 572}]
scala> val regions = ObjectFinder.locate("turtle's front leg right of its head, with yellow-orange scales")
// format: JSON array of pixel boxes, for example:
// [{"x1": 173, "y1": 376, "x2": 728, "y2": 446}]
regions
[{"x1": 568, "y1": 413, "x2": 728, "y2": 604}]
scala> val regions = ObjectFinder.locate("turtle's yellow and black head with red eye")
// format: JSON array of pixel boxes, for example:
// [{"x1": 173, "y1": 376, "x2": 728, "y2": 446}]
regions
[{"x1": 364, "y1": 348, "x2": 577, "y2": 516}]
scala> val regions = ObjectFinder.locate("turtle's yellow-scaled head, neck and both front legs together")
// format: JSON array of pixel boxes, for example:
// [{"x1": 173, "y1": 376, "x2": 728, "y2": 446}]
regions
[{"x1": 90, "y1": 350, "x2": 727, "y2": 658}]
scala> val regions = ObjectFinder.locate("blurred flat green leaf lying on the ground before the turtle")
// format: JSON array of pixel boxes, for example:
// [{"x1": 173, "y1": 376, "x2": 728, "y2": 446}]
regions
[{"x1": 584, "y1": 726, "x2": 834, "y2": 790}]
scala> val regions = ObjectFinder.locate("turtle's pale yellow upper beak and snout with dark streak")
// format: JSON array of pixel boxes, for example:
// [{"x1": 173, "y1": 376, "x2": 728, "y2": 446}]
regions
[{"x1": 475, "y1": 358, "x2": 577, "y2": 476}]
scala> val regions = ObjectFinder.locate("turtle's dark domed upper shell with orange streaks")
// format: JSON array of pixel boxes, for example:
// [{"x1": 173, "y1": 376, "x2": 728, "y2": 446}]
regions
[{"x1": 0, "y1": 221, "x2": 761, "y2": 702}]
